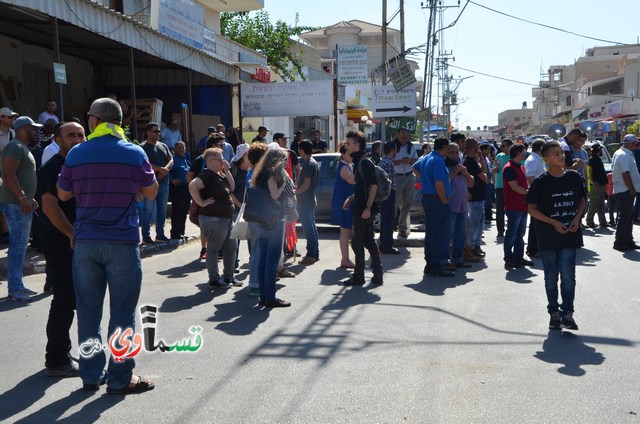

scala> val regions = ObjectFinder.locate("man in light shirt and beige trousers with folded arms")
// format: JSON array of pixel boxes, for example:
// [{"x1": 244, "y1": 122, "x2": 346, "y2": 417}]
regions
[{"x1": 393, "y1": 128, "x2": 418, "y2": 237}]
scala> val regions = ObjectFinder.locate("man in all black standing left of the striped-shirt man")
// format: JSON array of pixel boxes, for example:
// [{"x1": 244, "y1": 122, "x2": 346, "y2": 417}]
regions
[{"x1": 38, "y1": 122, "x2": 84, "y2": 377}]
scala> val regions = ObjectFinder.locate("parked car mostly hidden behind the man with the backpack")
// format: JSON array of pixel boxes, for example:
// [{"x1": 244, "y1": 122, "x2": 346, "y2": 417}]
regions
[{"x1": 313, "y1": 153, "x2": 424, "y2": 222}]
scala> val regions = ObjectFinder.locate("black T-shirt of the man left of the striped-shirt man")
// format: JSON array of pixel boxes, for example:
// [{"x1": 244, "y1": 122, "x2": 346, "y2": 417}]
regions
[{"x1": 38, "y1": 155, "x2": 76, "y2": 242}]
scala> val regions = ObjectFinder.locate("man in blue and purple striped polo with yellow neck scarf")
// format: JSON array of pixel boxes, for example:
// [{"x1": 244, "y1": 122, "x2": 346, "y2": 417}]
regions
[{"x1": 58, "y1": 98, "x2": 158, "y2": 394}]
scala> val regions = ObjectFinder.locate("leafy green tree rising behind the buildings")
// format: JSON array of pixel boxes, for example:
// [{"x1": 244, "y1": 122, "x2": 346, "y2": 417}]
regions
[{"x1": 220, "y1": 10, "x2": 315, "y2": 81}]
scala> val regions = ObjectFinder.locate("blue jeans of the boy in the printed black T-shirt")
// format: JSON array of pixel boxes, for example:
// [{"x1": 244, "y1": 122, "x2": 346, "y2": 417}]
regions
[{"x1": 540, "y1": 249, "x2": 576, "y2": 313}]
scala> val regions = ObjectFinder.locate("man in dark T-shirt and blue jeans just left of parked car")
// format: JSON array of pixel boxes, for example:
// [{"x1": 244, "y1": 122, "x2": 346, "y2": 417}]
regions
[{"x1": 296, "y1": 140, "x2": 320, "y2": 265}]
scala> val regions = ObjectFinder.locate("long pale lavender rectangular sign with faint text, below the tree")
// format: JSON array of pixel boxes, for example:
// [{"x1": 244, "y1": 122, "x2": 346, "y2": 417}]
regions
[{"x1": 240, "y1": 80, "x2": 333, "y2": 118}]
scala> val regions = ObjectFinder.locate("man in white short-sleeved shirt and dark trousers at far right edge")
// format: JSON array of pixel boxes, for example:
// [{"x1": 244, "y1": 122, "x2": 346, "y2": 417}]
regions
[{"x1": 611, "y1": 134, "x2": 640, "y2": 252}]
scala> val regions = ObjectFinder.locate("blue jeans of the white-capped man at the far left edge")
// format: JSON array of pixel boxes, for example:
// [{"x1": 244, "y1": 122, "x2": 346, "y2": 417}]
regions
[{"x1": 0, "y1": 204, "x2": 33, "y2": 292}]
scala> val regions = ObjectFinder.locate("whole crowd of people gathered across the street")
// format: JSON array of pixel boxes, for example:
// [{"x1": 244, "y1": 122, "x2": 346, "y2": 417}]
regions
[{"x1": 0, "y1": 98, "x2": 640, "y2": 394}]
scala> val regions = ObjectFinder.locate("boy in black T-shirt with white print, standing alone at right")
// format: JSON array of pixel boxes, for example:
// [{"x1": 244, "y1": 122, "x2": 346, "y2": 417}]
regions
[{"x1": 526, "y1": 141, "x2": 585, "y2": 330}]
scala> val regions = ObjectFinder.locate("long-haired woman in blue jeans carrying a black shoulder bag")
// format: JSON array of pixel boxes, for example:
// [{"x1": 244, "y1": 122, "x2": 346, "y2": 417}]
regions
[{"x1": 249, "y1": 149, "x2": 291, "y2": 308}]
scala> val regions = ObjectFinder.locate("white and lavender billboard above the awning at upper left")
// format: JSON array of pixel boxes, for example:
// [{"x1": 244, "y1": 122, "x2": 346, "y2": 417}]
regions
[{"x1": 151, "y1": 0, "x2": 204, "y2": 49}]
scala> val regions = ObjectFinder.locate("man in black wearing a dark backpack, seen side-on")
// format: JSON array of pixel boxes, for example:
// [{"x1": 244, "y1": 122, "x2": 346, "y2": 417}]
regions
[{"x1": 344, "y1": 131, "x2": 383, "y2": 286}]
